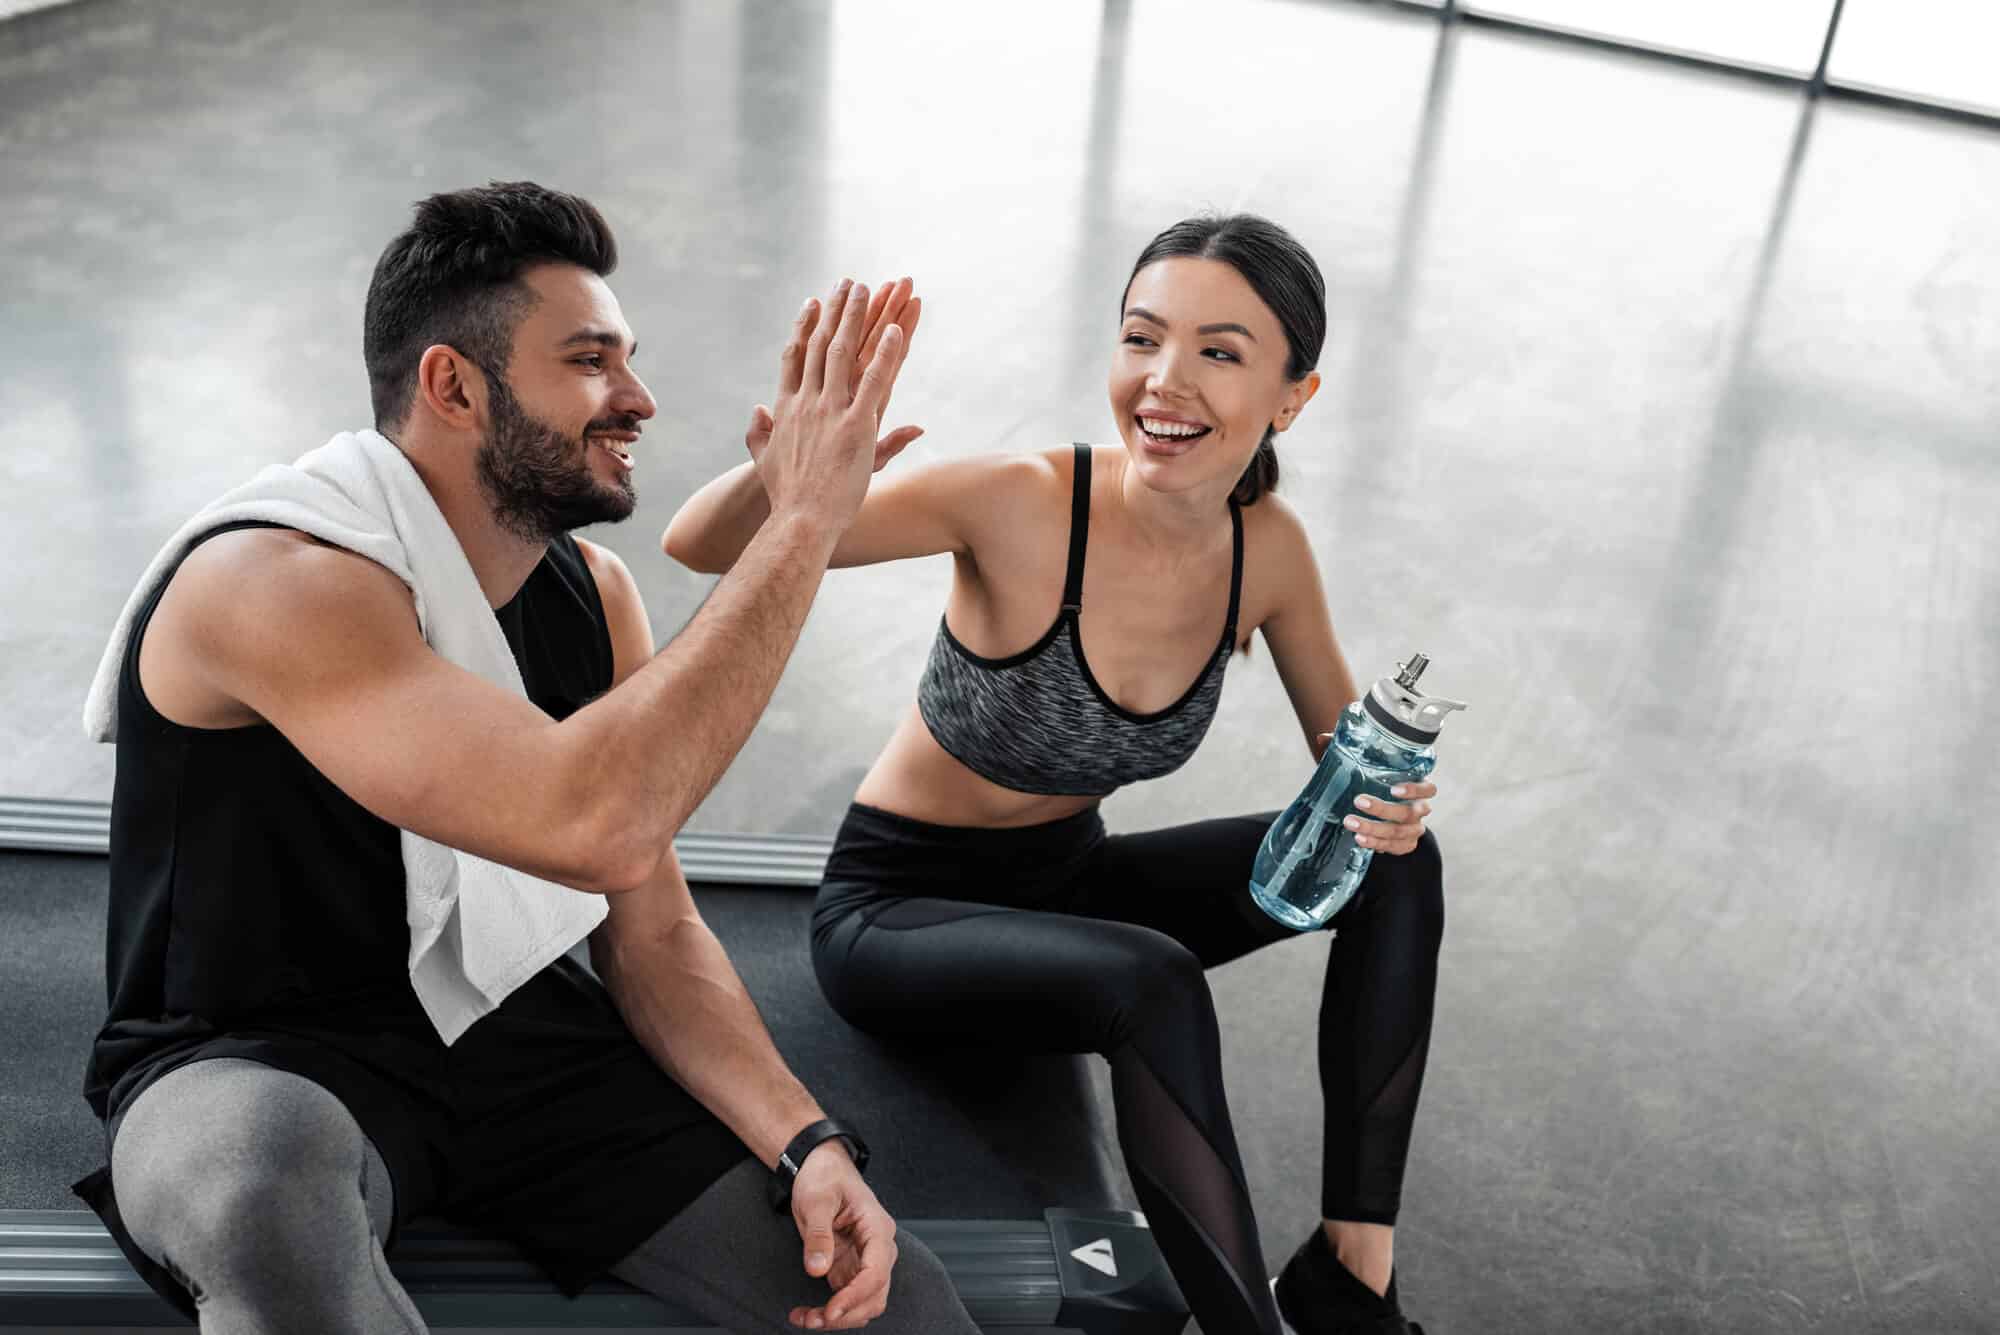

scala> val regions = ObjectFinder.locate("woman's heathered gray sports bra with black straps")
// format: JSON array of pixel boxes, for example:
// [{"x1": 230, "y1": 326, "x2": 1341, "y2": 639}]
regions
[{"x1": 916, "y1": 446, "x2": 1244, "y2": 797}]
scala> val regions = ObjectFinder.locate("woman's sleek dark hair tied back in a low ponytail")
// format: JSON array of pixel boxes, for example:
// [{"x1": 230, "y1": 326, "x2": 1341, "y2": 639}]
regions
[{"x1": 1118, "y1": 214, "x2": 1326, "y2": 506}]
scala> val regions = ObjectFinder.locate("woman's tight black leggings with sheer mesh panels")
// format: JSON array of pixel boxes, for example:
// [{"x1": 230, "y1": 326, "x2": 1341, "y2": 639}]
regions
[{"x1": 812, "y1": 803, "x2": 1444, "y2": 1335}]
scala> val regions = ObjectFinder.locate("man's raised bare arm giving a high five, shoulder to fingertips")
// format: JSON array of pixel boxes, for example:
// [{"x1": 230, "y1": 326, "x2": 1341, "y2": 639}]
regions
[{"x1": 172, "y1": 277, "x2": 900, "y2": 891}]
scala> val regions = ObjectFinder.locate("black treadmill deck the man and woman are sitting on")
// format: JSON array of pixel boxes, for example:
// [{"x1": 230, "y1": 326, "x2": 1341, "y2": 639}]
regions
[{"x1": 0, "y1": 851, "x2": 1186, "y2": 1335}]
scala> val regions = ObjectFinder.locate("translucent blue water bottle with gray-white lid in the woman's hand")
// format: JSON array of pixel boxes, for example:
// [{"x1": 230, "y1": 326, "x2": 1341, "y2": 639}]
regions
[{"x1": 1250, "y1": 654, "x2": 1466, "y2": 931}]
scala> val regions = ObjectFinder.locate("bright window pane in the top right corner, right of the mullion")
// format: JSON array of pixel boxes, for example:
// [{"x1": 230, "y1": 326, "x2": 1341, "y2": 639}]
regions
[{"x1": 1826, "y1": 0, "x2": 2000, "y2": 114}]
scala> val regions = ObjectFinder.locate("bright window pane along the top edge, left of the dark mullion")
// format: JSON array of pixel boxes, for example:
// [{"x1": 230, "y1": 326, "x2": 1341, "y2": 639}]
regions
[{"x1": 1460, "y1": 0, "x2": 1832, "y2": 74}]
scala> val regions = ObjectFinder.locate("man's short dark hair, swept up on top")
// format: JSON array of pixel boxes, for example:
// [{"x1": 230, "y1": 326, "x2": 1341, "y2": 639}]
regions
[{"x1": 362, "y1": 180, "x2": 618, "y2": 432}]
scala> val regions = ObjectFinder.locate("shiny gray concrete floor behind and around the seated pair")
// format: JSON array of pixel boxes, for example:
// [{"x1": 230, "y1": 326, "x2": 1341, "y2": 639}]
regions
[{"x1": 0, "y1": 0, "x2": 2000, "y2": 1333}]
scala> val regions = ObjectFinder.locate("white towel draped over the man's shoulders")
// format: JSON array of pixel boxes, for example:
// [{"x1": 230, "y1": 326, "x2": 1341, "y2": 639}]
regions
[{"x1": 84, "y1": 432, "x2": 606, "y2": 1043}]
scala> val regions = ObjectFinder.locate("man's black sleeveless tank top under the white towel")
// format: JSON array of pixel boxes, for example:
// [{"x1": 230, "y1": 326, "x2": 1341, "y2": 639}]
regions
[{"x1": 84, "y1": 524, "x2": 612, "y2": 1117}]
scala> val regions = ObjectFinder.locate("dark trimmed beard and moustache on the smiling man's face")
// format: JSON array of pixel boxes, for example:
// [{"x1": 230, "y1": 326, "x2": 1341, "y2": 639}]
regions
[{"x1": 474, "y1": 372, "x2": 638, "y2": 542}]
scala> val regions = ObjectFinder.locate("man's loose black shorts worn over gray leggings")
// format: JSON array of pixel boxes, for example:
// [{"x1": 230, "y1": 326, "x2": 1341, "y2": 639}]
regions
[{"x1": 76, "y1": 959, "x2": 748, "y2": 1317}]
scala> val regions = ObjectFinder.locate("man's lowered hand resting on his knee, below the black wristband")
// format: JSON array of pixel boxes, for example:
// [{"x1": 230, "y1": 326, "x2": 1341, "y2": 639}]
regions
[{"x1": 790, "y1": 1141, "x2": 896, "y2": 1331}]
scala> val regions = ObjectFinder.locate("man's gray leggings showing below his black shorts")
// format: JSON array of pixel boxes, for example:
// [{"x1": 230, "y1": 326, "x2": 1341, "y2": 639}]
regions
[{"x1": 112, "y1": 1057, "x2": 978, "y2": 1335}]
